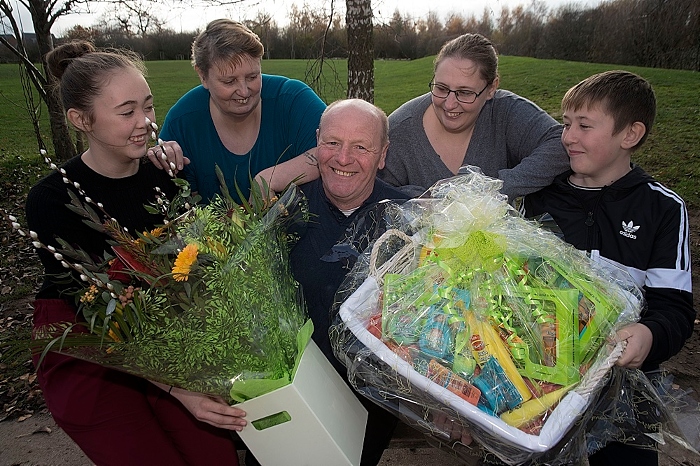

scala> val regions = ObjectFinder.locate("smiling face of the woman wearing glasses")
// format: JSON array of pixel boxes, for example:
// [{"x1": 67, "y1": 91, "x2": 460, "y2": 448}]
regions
[{"x1": 431, "y1": 57, "x2": 498, "y2": 133}]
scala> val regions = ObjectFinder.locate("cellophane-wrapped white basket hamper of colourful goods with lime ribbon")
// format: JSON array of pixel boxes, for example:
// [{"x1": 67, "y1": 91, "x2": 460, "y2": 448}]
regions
[{"x1": 331, "y1": 168, "x2": 696, "y2": 464}]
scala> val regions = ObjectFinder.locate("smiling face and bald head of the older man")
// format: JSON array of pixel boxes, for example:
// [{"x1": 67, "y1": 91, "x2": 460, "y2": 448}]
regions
[{"x1": 316, "y1": 99, "x2": 389, "y2": 210}]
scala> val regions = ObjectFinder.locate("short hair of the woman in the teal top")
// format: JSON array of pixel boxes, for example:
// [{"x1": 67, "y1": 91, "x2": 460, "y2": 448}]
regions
[{"x1": 192, "y1": 18, "x2": 265, "y2": 75}]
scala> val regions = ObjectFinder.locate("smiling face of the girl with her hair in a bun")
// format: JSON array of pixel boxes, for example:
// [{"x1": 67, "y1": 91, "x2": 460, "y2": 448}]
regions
[{"x1": 67, "y1": 68, "x2": 156, "y2": 173}]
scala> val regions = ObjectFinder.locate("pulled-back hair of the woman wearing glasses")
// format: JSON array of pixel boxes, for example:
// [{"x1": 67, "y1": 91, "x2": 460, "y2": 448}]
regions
[{"x1": 433, "y1": 33, "x2": 498, "y2": 84}]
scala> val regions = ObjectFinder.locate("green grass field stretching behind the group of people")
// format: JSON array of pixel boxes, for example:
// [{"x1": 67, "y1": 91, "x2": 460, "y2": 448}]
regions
[{"x1": 0, "y1": 56, "x2": 700, "y2": 207}]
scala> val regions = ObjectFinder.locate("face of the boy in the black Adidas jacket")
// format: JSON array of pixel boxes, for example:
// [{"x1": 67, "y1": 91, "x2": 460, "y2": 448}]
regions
[{"x1": 561, "y1": 105, "x2": 638, "y2": 187}]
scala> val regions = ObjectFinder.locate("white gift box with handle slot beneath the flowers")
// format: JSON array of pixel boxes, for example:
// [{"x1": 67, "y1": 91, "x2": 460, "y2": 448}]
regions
[{"x1": 237, "y1": 340, "x2": 367, "y2": 466}]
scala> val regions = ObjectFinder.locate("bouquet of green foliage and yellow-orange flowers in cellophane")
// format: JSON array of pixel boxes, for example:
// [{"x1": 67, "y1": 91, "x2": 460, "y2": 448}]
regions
[{"x1": 22, "y1": 162, "x2": 312, "y2": 402}]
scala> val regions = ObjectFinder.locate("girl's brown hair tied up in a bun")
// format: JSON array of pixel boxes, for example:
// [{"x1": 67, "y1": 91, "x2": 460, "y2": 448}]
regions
[{"x1": 46, "y1": 40, "x2": 146, "y2": 125}]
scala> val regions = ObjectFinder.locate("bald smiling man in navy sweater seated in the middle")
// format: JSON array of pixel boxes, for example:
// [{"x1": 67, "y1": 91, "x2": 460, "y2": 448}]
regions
[{"x1": 291, "y1": 99, "x2": 408, "y2": 466}]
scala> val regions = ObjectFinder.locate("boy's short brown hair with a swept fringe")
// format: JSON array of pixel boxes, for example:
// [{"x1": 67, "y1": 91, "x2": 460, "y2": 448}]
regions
[{"x1": 561, "y1": 70, "x2": 656, "y2": 149}]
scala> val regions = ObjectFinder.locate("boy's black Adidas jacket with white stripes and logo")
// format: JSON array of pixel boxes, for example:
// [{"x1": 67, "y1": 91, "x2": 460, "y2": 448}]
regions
[{"x1": 521, "y1": 166, "x2": 695, "y2": 371}]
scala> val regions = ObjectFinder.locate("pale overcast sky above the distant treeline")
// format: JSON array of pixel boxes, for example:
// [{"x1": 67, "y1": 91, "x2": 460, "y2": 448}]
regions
[{"x1": 23, "y1": 0, "x2": 600, "y2": 36}]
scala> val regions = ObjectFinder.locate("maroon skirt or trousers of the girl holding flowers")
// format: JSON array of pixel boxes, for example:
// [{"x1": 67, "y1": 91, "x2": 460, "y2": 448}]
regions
[{"x1": 34, "y1": 299, "x2": 238, "y2": 466}]
